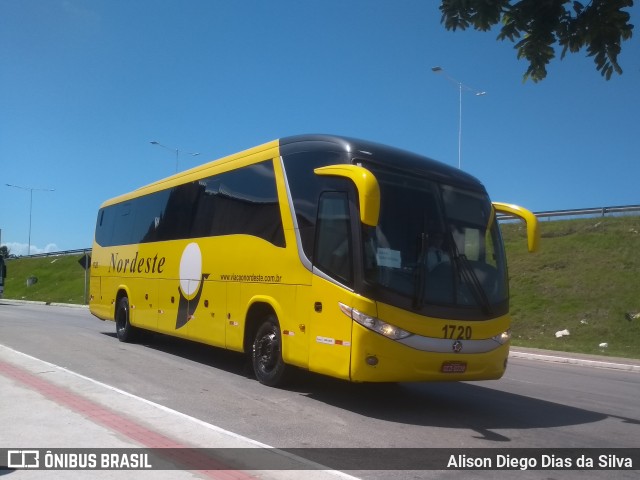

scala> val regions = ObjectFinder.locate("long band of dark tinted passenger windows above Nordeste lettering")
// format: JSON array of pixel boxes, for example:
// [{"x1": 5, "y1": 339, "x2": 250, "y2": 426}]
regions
[{"x1": 96, "y1": 161, "x2": 285, "y2": 247}]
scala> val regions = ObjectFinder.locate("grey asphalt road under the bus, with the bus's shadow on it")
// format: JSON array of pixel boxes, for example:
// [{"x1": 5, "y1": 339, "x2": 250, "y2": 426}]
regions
[{"x1": 0, "y1": 301, "x2": 640, "y2": 480}]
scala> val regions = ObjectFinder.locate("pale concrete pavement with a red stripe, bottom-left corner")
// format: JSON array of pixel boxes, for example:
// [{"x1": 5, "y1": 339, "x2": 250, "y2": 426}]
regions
[{"x1": 0, "y1": 344, "x2": 358, "y2": 480}]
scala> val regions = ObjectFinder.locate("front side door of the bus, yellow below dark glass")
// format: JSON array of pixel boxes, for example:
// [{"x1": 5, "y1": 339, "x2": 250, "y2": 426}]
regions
[{"x1": 309, "y1": 191, "x2": 354, "y2": 379}]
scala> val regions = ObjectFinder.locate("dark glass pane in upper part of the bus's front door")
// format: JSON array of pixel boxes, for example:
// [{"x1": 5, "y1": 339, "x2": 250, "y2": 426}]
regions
[{"x1": 313, "y1": 192, "x2": 353, "y2": 285}]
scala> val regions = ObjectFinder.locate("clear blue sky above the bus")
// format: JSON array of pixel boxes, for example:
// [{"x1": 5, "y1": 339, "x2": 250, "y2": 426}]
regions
[{"x1": 0, "y1": 0, "x2": 640, "y2": 255}]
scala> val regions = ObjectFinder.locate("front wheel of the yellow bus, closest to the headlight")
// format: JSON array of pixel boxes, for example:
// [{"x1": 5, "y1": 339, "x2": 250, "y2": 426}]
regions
[{"x1": 251, "y1": 315, "x2": 287, "y2": 387}]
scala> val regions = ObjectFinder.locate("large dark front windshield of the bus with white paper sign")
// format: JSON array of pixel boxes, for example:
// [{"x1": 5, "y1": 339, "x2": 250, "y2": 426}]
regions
[{"x1": 363, "y1": 165, "x2": 508, "y2": 319}]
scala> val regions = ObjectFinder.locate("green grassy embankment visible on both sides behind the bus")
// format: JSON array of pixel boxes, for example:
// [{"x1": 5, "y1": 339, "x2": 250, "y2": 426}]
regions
[{"x1": 5, "y1": 217, "x2": 640, "y2": 358}]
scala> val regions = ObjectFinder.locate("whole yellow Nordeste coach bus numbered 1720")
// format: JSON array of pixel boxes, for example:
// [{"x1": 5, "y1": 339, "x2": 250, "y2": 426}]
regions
[{"x1": 90, "y1": 135, "x2": 539, "y2": 386}]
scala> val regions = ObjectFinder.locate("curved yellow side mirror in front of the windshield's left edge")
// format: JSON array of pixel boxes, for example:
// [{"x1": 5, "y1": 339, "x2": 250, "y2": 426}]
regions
[{"x1": 313, "y1": 164, "x2": 380, "y2": 227}]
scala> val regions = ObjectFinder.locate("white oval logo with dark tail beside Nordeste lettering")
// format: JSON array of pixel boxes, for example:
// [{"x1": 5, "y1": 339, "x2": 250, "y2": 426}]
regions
[{"x1": 176, "y1": 243, "x2": 209, "y2": 330}]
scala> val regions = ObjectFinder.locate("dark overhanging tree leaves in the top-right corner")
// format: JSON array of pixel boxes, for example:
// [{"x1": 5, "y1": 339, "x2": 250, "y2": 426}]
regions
[{"x1": 440, "y1": 0, "x2": 633, "y2": 82}]
